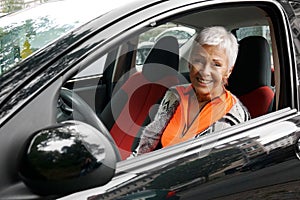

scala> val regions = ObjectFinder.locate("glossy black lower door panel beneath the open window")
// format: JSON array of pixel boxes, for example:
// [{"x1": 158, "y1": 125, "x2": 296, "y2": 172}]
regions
[{"x1": 61, "y1": 108, "x2": 300, "y2": 199}]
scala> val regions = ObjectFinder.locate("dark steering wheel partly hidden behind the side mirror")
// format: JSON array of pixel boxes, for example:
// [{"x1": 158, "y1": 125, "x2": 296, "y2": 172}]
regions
[{"x1": 59, "y1": 87, "x2": 121, "y2": 160}]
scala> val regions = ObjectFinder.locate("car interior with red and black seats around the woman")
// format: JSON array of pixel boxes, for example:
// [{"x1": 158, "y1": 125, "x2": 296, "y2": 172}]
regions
[{"x1": 57, "y1": 4, "x2": 286, "y2": 159}]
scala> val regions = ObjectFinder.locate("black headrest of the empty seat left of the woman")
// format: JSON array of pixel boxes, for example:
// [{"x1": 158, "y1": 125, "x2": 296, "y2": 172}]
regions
[{"x1": 142, "y1": 36, "x2": 179, "y2": 81}]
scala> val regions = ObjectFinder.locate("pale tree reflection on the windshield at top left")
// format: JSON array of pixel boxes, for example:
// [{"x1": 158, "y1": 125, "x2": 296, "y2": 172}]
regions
[{"x1": 0, "y1": 17, "x2": 73, "y2": 73}]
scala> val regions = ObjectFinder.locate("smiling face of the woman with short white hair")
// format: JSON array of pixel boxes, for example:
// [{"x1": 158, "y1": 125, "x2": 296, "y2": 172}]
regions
[{"x1": 190, "y1": 45, "x2": 232, "y2": 101}]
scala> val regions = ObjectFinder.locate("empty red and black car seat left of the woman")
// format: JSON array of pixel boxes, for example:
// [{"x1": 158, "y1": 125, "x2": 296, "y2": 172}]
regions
[{"x1": 100, "y1": 36, "x2": 180, "y2": 159}]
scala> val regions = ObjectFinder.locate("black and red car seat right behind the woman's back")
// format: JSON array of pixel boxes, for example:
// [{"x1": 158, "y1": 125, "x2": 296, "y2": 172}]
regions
[{"x1": 228, "y1": 36, "x2": 274, "y2": 118}]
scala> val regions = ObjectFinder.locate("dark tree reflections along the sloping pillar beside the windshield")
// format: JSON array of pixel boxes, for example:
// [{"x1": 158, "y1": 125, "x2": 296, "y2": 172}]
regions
[{"x1": 0, "y1": 29, "x2": 96, "y2": 117}]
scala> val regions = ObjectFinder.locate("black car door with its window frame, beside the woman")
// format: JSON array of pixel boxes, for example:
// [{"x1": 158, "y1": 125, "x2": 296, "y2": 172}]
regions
[{"x1": 57, "y1": 1, "x2": 299, "y2": 199}]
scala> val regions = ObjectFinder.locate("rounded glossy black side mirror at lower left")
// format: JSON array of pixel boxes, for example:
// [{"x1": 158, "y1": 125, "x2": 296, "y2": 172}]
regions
[{"x1": 18, "y1": 121, "x2": 117, "y2": 195}]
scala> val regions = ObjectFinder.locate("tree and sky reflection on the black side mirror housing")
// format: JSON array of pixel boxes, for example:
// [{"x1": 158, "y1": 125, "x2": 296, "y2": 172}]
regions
[{"x1": 28, "y1": 127, "x2": 104, "y2": 180}]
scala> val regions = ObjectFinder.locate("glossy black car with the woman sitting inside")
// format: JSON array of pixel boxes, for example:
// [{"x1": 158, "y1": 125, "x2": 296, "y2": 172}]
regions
[{"x1": 0, "y1": 0, "x2": 300, "y2": 200}]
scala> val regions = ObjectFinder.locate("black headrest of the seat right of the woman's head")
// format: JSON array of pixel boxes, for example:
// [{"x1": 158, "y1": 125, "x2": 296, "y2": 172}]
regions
[{"x1": 228, "y1": 36, "x2": 271, "y2": 96}]
